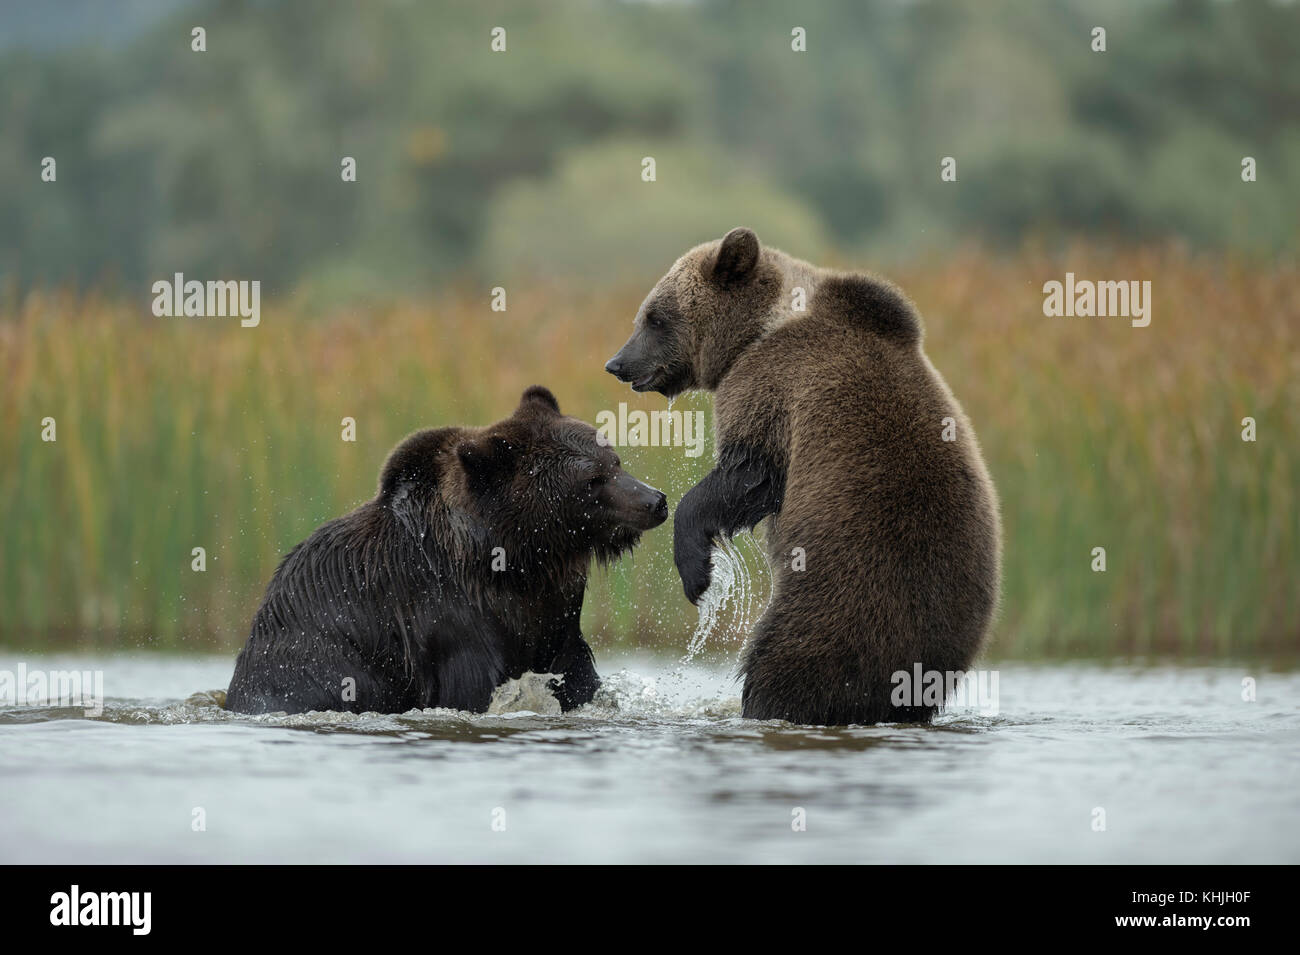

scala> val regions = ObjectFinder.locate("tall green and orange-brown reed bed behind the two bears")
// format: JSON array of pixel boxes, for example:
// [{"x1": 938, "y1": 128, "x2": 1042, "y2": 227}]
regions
[{"x1": 0, "y1": 247, "x2": 1300, "y2": 657}]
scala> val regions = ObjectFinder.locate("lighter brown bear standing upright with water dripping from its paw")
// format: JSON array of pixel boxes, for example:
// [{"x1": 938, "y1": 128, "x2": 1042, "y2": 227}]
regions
[{"x1": 606, "y1": 229, "x2": 1001, "y2": 725}]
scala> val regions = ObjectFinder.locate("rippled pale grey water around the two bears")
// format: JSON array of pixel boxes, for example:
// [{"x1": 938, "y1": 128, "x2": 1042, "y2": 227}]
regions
[{"x1": 0, "y1": 652, "x2": 1300, "y2": 864}]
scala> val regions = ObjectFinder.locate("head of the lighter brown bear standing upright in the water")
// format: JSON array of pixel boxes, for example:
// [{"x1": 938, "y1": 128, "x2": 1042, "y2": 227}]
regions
[{"x1": 605, "y1": 229, "x2": 785, "y2": 398}]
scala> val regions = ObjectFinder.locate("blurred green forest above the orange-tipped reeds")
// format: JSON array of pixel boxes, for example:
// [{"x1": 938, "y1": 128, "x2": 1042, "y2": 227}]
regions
[{"x1": 0, "y1": 0, "x2": 1300, "y2": 294}]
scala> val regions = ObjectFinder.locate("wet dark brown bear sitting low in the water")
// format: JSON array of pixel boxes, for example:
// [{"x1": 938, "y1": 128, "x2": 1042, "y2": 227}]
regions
[{"x1": 226, "y1": 386, "x2": 668, "y2": 713}]
